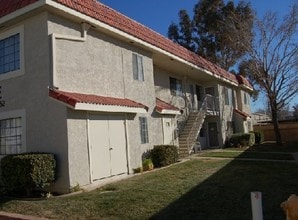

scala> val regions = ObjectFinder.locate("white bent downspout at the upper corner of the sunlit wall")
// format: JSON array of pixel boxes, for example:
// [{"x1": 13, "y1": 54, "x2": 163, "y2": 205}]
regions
[{"x1": 50, "y1": 22, "x2": 91, "y2": 88}]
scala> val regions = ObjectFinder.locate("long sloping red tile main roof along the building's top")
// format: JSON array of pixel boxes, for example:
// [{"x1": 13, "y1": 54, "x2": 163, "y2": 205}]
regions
[{"x1": 0, "y1": 0, "x2": 252, "y2": 88}]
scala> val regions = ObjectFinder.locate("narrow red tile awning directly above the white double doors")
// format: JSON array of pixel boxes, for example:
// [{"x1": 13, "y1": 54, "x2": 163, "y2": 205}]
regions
[{"x1": 49, "y1": 89, "x2": 148, "y2": 110}]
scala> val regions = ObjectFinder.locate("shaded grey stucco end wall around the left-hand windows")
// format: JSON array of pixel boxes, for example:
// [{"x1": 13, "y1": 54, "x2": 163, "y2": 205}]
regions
[{"x1": 0, "y1": 12, "x2": 69, "y2": 191}]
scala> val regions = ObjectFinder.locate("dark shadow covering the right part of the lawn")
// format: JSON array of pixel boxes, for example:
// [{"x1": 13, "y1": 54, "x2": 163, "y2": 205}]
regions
[{"x1": 150, "y1": 145, "x2": 298, "y2": 220}]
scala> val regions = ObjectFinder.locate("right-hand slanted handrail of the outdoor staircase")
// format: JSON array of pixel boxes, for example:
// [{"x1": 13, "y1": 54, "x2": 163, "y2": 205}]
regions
[{"x1": 186, "y1": 94, "x2": 208, "y2": 152}]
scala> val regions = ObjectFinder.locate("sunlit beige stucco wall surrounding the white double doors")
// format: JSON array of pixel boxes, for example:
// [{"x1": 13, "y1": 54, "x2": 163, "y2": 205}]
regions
[{"x1": 48, "y1": 15, "x2": 162, "y2": 177}]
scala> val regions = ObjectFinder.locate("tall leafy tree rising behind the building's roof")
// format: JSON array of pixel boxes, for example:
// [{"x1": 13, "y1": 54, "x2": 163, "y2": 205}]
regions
[{"x1": 168, "y1": 0, "x2": 254, "y2": 70}]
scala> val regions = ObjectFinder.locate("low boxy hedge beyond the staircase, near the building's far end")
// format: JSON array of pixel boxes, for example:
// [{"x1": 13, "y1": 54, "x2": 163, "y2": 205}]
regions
[{"x1": 229, "y1": 133, "x2": 255, "y2": 147}]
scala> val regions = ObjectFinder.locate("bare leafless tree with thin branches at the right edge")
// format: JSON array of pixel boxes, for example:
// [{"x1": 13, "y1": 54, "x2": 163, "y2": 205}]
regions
[{"x1": 239, "y1": 4, "x2": 298, "y2": 145}]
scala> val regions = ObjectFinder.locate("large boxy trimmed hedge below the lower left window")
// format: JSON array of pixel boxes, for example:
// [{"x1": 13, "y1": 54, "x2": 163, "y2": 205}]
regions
[{"x1": 1, "y1": 153, "x2": 56, "y2": 195}]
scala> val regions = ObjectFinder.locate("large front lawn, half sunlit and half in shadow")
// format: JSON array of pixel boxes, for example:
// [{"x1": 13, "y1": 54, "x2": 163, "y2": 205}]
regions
[{"x1": 0, "y1": 158, "x2": 298, "y2": 220}]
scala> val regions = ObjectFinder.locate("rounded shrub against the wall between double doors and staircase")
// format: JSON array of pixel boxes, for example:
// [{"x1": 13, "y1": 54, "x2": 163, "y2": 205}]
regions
[{"x1": 151, "y1": 145, "x2": 178, "y2": 167}]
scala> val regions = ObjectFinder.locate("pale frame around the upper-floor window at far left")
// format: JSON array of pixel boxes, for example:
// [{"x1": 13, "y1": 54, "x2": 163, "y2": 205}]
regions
[{"x1": 0, "y1": 25, "x2": 25, "y2": 81}]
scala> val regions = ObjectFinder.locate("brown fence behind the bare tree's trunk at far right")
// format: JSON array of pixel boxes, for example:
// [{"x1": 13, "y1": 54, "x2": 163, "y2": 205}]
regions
[{"x1": 254, "y1": 121, "x2": 298, "y2": 141}]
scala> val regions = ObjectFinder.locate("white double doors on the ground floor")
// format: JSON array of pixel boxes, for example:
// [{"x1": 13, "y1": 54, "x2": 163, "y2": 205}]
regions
[{"x1": 89, "y1": 114, "x2": 127, "y2": 181}]
